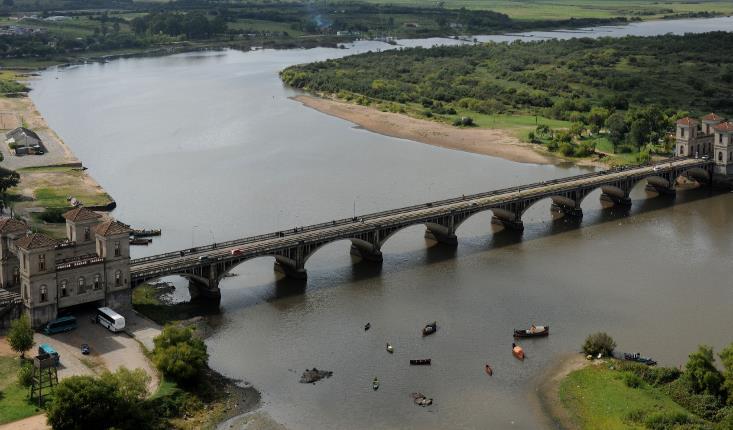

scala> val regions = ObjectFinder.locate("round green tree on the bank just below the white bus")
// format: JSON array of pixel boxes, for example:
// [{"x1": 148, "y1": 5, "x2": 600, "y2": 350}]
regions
[{"x1": 153, "y1": 325, "x2": 209, "y2": 383}]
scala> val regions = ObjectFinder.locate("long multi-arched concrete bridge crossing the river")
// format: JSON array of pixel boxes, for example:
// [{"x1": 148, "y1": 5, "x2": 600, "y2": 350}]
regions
[{"x1": 130, "y1": 158, "x2": 713, "y2": 297}]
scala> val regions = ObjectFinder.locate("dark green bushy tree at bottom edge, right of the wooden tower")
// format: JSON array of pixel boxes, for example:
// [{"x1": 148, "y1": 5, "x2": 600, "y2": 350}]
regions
[{"x1": 46, "y1": 376, "x2": 119, "y2": 430}]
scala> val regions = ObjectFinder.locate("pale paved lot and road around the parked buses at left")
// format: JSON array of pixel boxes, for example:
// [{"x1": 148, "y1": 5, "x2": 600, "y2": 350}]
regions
[{"x1": 32, "y1": 310, "x2": 161, "y2": 392}]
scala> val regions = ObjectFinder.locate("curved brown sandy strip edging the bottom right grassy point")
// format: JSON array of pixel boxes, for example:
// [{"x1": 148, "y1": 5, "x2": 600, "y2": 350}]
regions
[{"x1": 536, "y1": 353, "x2": 592, "y2": 430}]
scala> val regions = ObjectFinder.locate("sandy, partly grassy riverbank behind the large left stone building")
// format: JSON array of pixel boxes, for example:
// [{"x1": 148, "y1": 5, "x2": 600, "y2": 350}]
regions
[{"x1": 0, "y1": 84, "x2": 116, "y2": 237}]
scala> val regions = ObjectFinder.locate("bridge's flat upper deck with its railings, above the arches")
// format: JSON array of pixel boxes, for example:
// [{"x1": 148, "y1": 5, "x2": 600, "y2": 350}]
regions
[{"x1": 130, "y1": 158, "x2": 711, "y2": 278}]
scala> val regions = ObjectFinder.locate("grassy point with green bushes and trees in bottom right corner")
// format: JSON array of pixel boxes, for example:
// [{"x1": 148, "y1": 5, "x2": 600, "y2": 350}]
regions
[{"x1": 559, "y1": 336, "x2": 733, "y2": 430}]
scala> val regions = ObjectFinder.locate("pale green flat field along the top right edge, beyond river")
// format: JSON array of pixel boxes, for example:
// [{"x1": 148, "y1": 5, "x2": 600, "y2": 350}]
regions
[{"x1": 366, "y1": 0, "x2": 733, "y2": 20}]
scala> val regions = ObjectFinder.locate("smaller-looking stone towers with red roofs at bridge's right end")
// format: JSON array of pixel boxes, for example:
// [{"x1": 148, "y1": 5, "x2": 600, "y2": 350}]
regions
[{"x1": 675, "y1": 113, "x2": 733, "y2": 175}]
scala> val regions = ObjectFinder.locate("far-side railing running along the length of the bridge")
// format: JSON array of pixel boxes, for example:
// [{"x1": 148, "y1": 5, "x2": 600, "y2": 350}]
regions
[{"x1": 130, "y1": 157, "x2": 711, "y2": 265}]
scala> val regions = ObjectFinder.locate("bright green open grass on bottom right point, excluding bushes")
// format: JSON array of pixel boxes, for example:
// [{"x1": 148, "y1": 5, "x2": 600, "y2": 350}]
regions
[{"x1": 560, "y1": 365, "x2": 697, "y2": 430}]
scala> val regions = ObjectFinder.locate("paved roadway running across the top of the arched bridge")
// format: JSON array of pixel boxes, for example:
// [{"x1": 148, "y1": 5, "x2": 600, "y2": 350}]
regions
[{"x1": 130, "y1": 158, "x2": 702, "y2": 275}]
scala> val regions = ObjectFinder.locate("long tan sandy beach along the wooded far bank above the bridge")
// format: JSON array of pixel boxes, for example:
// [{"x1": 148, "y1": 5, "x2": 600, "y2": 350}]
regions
[{"x1": 294, "y1": 95, "x2": 560, "y2": 164}]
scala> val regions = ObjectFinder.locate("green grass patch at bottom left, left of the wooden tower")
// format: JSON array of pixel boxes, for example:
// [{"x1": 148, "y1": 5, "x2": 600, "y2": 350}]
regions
[{"x1": 0, "y1": 357, "x2": 41, "y2": 424}]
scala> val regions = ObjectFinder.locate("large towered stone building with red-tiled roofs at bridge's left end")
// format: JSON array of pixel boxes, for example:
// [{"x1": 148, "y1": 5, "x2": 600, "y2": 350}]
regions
[{"x1": 0, "y1": 207, "x2": 131, "y2": 327}]
